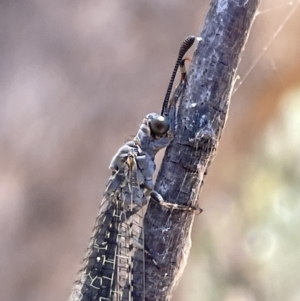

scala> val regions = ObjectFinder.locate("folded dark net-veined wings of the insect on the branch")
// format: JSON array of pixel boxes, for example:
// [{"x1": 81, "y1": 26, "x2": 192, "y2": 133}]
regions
[{"x1": 69, "y1": 148, "x2": 145, "y2": 301}]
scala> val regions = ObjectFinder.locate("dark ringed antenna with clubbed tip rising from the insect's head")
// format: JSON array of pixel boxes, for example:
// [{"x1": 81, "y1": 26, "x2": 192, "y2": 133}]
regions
[{"x1": 161, "y1": 36, "x2": 196, "y2": 116}]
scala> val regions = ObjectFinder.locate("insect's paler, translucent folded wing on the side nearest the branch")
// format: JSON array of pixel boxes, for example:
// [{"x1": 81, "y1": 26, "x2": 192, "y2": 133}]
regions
[{"x1": 113, "y1": 156, "x2": 145, "y2": 301}]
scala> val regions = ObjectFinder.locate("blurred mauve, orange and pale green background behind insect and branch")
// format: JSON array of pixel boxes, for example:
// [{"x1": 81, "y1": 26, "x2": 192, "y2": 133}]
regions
[{"x1": 0, "y1": 0, "x2": 300, "y2": 301}]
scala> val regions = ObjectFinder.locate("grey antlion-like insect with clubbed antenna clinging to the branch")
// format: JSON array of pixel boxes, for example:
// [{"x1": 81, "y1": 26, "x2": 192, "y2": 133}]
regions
[{"x1": 69, "y1": 36, "x2": 195, "y2": 301}]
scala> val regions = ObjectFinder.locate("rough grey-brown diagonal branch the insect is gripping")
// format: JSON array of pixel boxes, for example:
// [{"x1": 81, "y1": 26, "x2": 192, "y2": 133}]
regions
[{"x1": 137, "y1": 0, "x2": 259, "y2": 300}]
